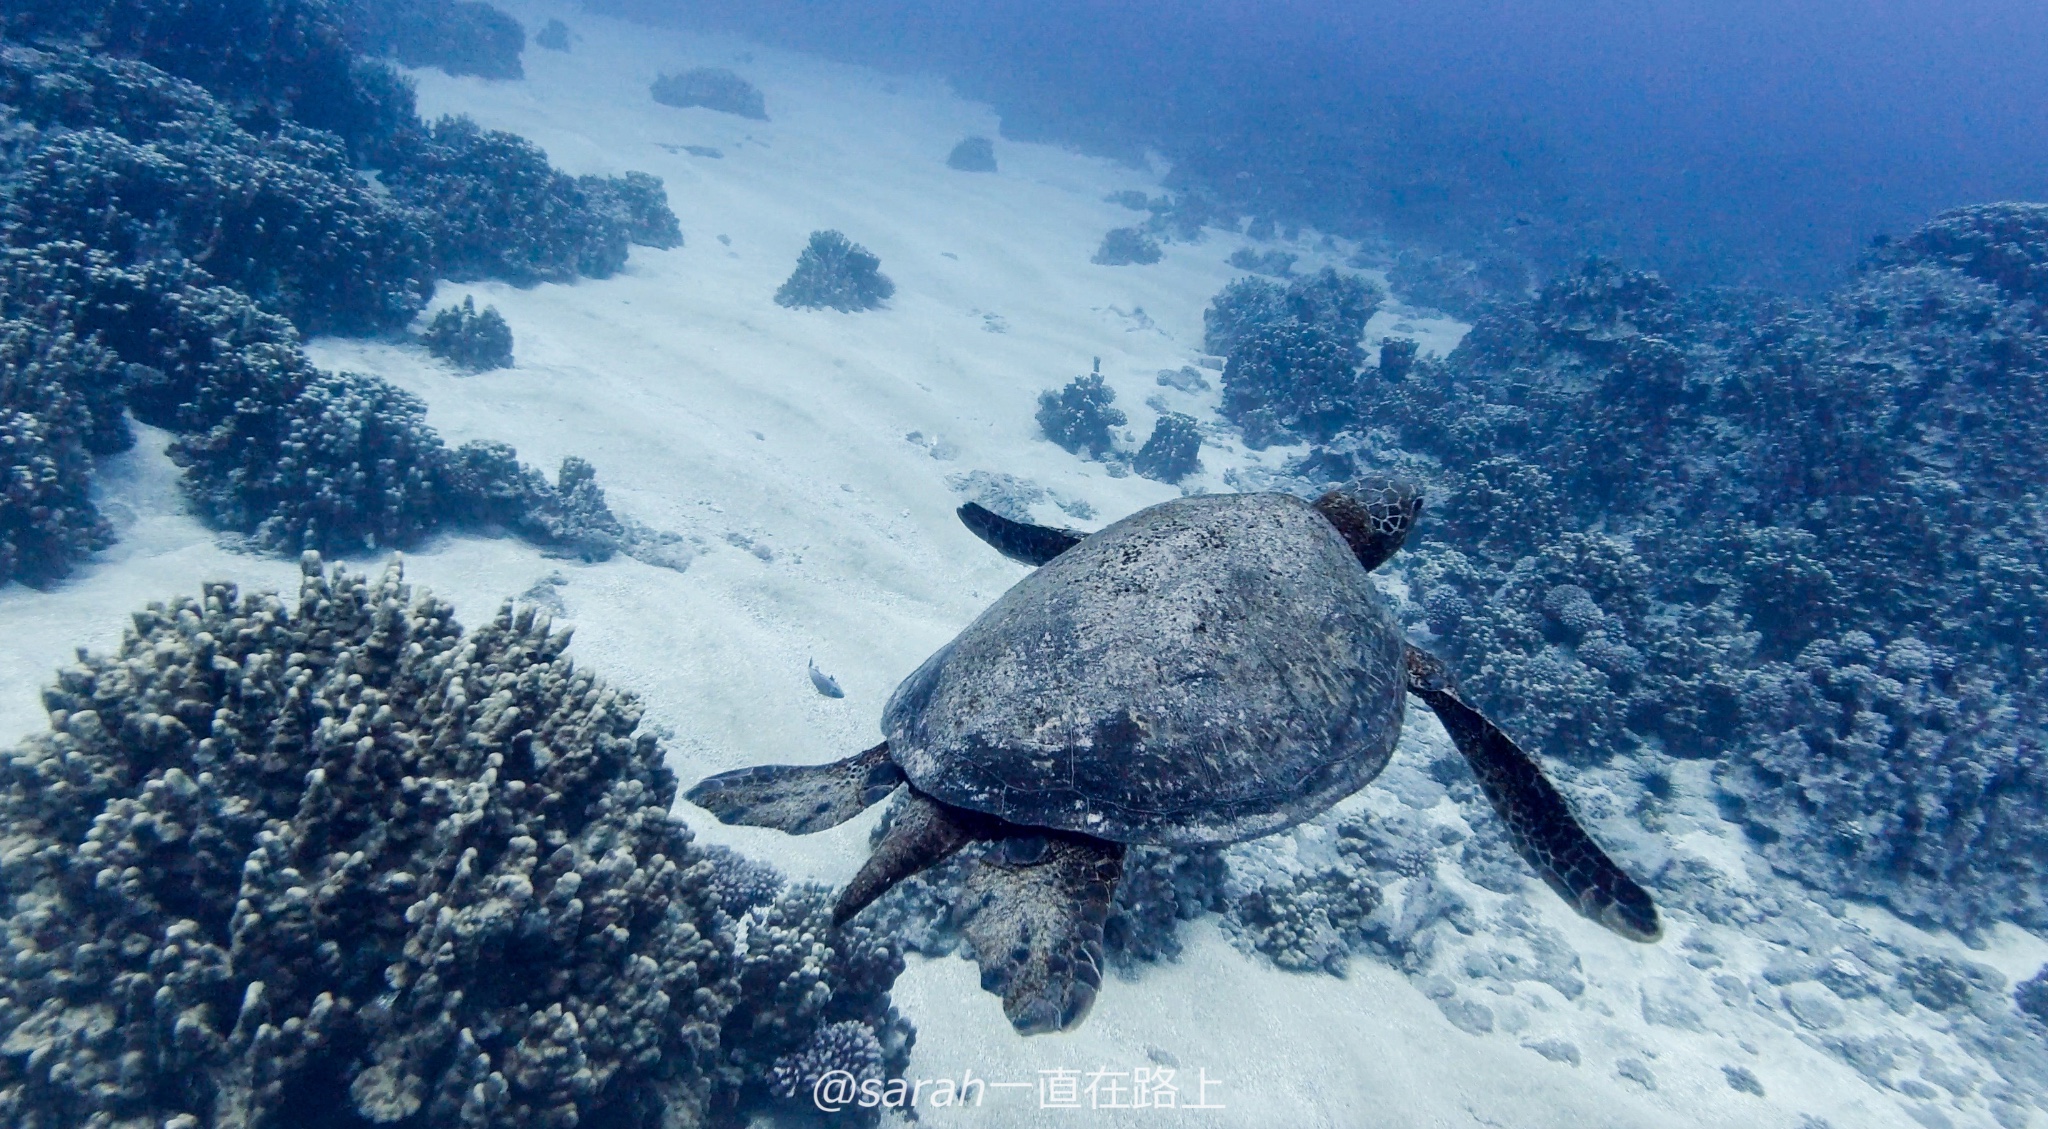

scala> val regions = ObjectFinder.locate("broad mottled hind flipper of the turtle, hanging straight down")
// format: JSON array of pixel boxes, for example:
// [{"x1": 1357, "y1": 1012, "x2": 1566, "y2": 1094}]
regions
[{"x1": 963, "y1": 834, "x2": 1124, "y2": 1035}]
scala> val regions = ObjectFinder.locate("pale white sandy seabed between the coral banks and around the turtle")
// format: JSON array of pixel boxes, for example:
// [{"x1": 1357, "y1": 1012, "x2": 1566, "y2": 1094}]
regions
[{"x1": 0, "y1": 8, "x2": 2015, "y2": 1129}]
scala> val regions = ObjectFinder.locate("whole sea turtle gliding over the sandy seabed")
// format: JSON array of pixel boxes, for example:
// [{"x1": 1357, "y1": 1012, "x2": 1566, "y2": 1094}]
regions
[{"x1": 688, "y1": 479, "x2": 1661, "y2": 1035}]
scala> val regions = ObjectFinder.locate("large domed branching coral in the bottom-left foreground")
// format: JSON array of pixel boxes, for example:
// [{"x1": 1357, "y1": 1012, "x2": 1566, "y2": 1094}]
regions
[{"x1": 0, "y1": 557, "x2": 739, "y2": 1127}]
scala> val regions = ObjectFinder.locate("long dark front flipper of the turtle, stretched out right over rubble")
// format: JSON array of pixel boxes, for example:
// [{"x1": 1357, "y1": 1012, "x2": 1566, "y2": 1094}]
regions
[{"x1": 1407, "y1": 647, "x2": 1663, "y2": 940}]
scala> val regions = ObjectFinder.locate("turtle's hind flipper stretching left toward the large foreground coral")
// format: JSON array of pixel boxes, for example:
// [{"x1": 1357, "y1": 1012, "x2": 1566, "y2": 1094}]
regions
[{"x1": 684, "y1": 742, "x2": 903, "y2": 836}]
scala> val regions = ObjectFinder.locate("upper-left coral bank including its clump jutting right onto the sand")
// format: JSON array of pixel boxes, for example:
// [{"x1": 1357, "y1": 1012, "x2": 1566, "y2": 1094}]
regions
[{"x1": 0, "y1": 42, "x2": 682, "y2": 303}]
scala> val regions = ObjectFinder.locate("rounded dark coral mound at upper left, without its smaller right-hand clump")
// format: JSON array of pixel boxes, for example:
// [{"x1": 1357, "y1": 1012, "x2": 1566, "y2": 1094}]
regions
[{"x1": 0, "y1": 47, "x2": 430, "y2": 332}]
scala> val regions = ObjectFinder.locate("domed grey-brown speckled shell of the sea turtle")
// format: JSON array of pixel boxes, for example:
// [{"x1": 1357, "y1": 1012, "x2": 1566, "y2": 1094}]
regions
[{"x1": 883, "y1": 494, "x2": 1407, "y2": 846}]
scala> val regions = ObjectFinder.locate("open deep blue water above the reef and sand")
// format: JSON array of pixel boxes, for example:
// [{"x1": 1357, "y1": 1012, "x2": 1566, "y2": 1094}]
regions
[{"x1": 592, "y1": 0, "x2": 2048, "y2": 289}]
